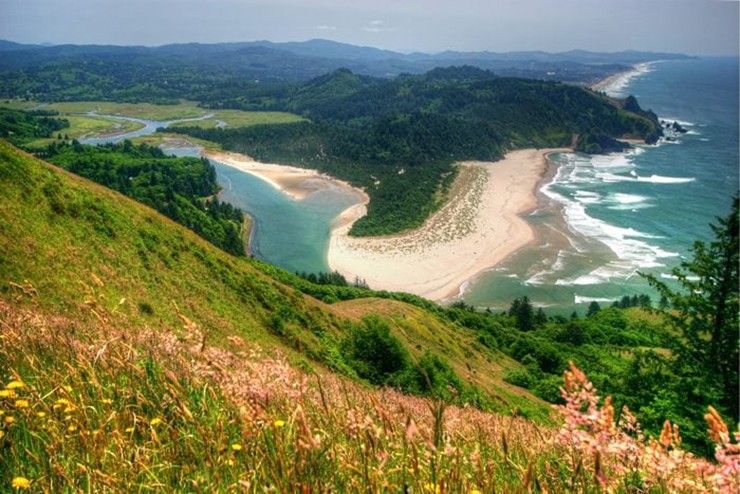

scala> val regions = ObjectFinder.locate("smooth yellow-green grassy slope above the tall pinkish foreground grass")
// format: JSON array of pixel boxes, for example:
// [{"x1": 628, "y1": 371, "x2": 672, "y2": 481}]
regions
[{"x1": 0, "y1": 139, "x2": 546, "y2": 416}]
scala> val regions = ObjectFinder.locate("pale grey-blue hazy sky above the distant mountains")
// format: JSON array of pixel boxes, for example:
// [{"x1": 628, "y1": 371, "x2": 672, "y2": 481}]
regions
[{"x1": 0, "y1": 0, "x2": 740, "y2": 56}]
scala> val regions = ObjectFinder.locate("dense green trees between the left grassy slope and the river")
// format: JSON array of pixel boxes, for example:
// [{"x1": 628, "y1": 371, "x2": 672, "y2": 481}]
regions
[{"x1": 38, "y1": 141, "x2": 244, "y2": 256}]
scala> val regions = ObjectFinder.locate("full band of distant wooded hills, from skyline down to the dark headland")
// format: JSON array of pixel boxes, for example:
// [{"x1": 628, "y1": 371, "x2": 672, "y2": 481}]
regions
[{"x1": 0, "y1": 40, "x2": 685, "y2": 103}]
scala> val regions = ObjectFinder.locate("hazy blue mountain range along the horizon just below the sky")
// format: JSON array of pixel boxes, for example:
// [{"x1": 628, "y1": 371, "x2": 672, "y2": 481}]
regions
[{"x1": 0, "y1": 39, "x2": 690, "y2": 84}]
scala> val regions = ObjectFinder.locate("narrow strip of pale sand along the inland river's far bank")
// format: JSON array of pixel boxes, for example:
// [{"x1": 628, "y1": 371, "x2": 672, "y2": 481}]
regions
[{"x1": 202, "y1": 149, "x2": 368, "y2": 203}]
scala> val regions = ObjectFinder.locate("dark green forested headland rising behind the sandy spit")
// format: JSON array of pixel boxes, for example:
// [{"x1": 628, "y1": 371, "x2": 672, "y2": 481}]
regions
[{"x1": 172, "y1": 66, "x2": 660, "y2": 235}]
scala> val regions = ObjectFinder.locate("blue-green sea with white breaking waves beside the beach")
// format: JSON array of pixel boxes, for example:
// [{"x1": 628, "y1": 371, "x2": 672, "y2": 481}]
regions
[{"x1": 463, "y1": 58, "x2": 739, "y2": 313}]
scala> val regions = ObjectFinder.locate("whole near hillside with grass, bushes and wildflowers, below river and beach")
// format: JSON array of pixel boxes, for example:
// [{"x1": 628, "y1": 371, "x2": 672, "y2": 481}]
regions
[{"x1": 0, "y1": 141, "x2": 738, "y2": 492}]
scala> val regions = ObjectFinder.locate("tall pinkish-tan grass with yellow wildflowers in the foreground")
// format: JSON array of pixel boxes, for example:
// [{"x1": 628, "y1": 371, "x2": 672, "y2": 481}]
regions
[{"x1": 0, "y1": 286, "x2": 740, "y2": 493}]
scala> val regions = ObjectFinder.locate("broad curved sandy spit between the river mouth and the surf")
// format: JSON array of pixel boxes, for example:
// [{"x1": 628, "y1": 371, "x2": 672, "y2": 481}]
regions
[{"x1": 328, "y1": 149, "x2": 570, "y2": 301}]
